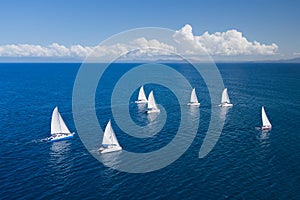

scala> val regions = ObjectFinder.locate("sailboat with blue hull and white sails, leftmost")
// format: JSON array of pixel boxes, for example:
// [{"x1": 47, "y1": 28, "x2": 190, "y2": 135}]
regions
[{"x1": 49, "y1": 106, "x2": 75, "y2": 142}]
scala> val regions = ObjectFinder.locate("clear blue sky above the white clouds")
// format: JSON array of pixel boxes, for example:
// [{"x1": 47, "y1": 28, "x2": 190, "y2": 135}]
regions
[{"x1": 0, "y1": 0, "x2": 300, "y2": 60}]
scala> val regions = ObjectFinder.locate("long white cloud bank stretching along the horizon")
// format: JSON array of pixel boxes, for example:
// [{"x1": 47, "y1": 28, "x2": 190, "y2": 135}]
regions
[{"x1": 0, "y1": 24, "x2": 278, "y2": 59}]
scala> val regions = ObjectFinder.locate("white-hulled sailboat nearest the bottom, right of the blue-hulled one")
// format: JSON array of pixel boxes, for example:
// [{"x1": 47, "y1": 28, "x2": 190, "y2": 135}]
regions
[{"x1": 99, "y1": 120, "x2": 122, "y2": 153}]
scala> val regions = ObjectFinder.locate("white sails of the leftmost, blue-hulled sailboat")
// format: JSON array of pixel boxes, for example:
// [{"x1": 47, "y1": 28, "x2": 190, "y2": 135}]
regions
[{"x1": 51, "y1": 107, "x2": 71, "y2": 134}]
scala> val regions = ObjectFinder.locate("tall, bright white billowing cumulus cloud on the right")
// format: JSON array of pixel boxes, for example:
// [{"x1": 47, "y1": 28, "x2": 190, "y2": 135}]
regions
[{"x1": 173, "y1": 24, "x2": 278, "y2": 56}]
